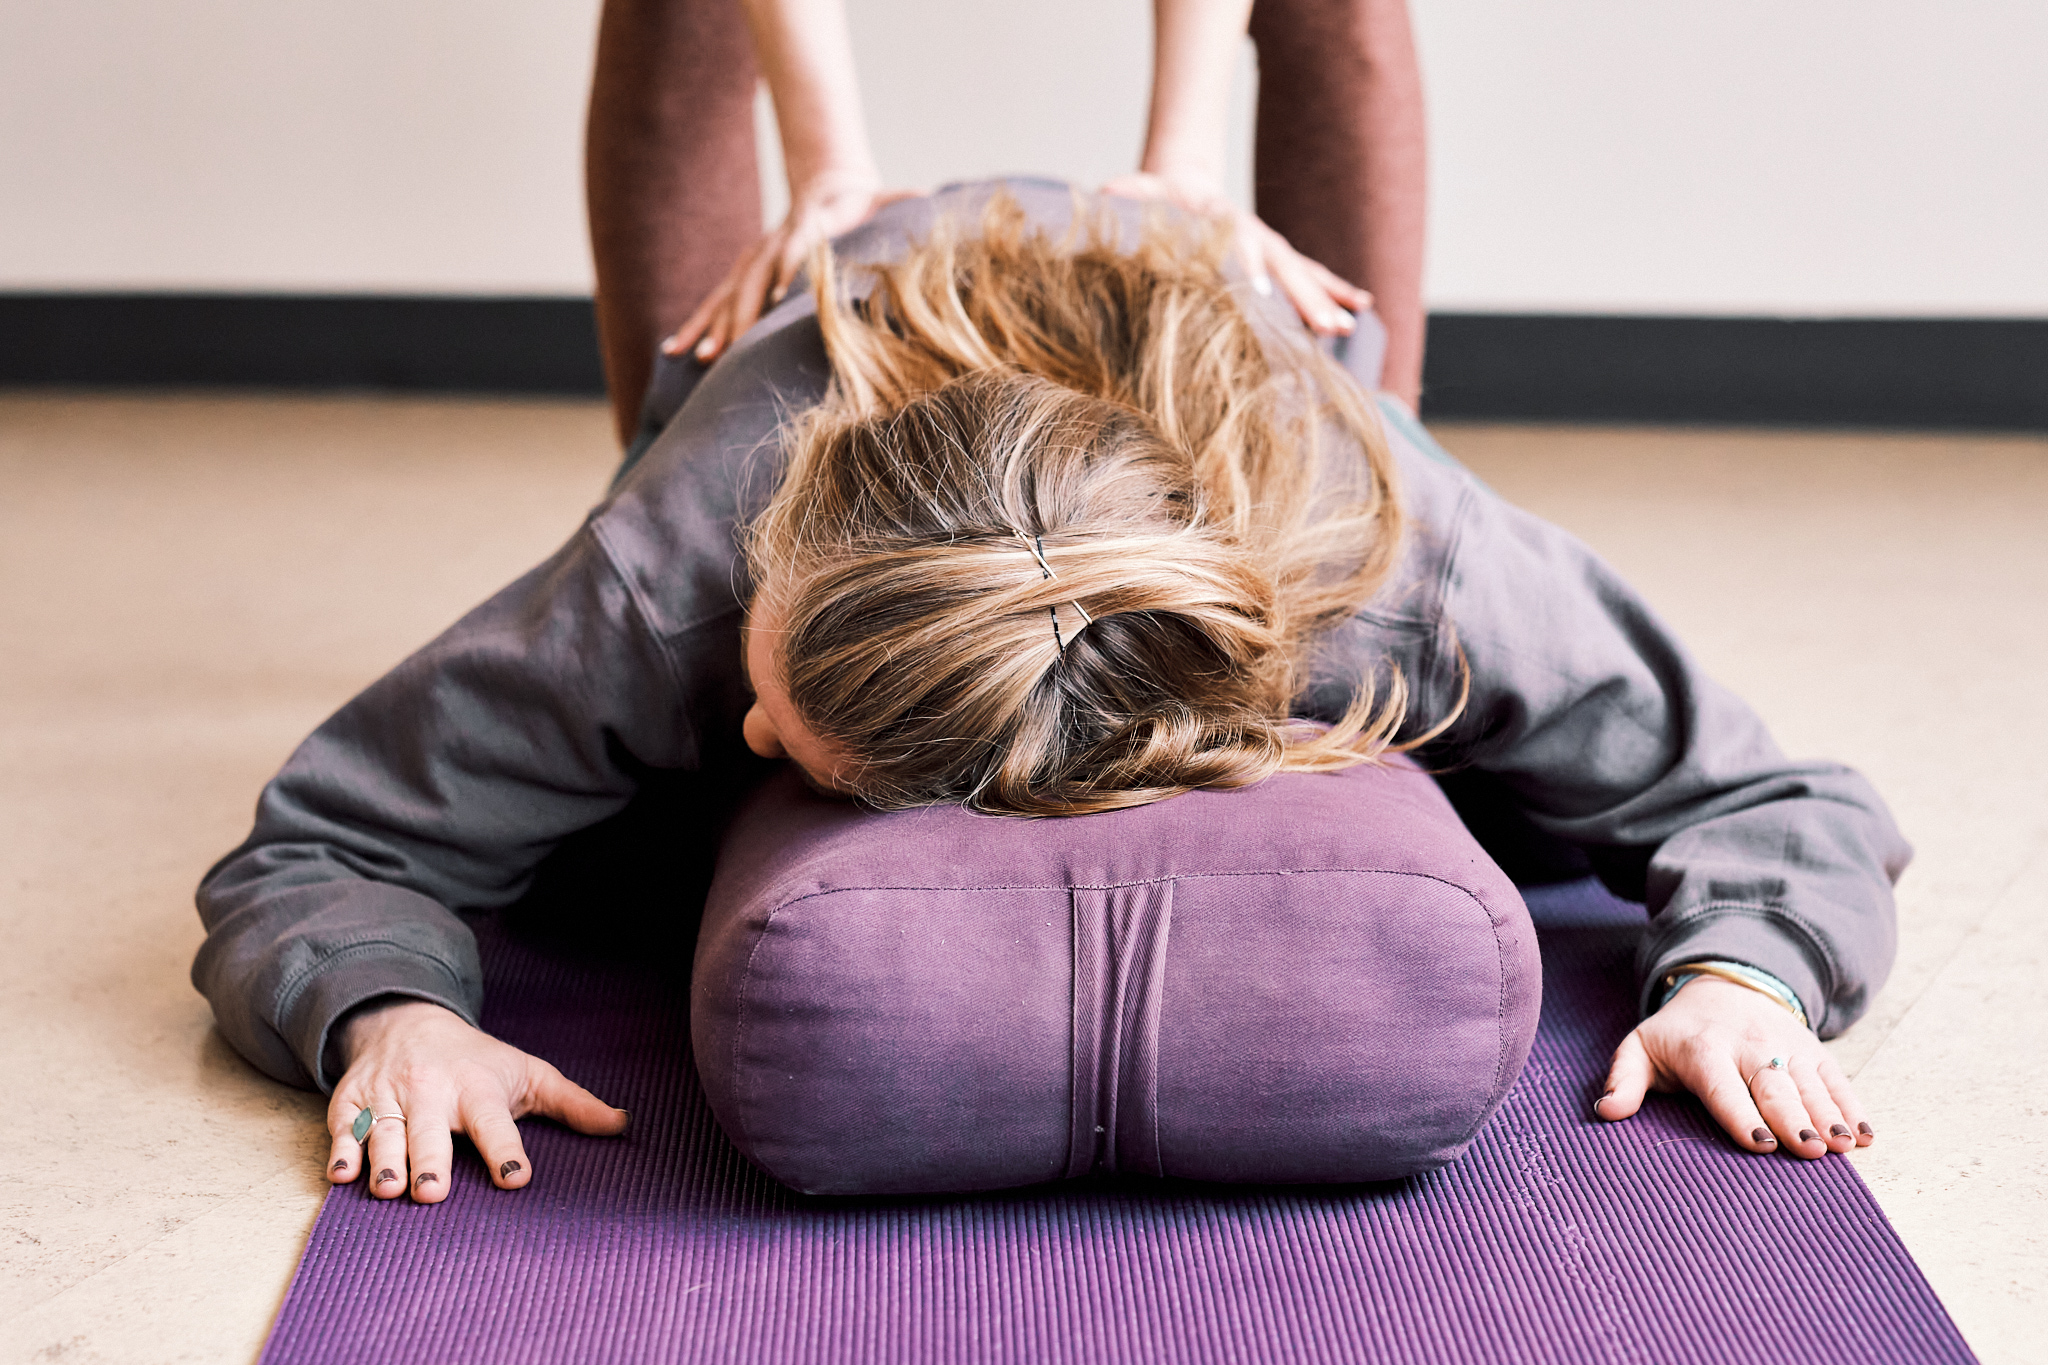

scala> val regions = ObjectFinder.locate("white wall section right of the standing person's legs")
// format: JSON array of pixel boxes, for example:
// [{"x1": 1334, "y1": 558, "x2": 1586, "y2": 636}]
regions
[{"x1": 1413, "y1": 0, "x2": 2048, "y2": 315}]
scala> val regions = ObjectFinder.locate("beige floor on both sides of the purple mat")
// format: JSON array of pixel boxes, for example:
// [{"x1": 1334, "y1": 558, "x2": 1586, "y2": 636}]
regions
[{"x1": 0, "y1": 395, "x2": 2048, "y2": 1363}]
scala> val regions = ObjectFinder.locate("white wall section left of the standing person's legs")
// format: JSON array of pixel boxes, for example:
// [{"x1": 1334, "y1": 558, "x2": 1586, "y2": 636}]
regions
[{"x1": 0, "y1": 0, "x2": 596, "y2": 293}]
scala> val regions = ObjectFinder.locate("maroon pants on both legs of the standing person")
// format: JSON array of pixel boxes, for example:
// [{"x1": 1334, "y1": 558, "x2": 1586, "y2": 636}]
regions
[{"x1": 586, "y1": 0, "x2": 1423, "y2": 440}]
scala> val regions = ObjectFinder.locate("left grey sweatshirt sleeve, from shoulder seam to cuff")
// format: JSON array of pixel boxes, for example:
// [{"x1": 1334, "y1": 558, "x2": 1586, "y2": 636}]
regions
[{"x1": 193, "y1": 524, "x2": 704, "y2": 1089}]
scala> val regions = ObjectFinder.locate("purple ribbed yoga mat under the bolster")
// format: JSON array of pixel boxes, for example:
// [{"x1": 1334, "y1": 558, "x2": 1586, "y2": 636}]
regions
[{"x1": 262, "y1": 882, "x2": 1974, "y2": 1365}]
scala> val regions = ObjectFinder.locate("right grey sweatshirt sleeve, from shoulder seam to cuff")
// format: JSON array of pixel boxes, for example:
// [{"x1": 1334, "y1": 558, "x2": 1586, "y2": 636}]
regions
[{"x1": 1430, "y1": 475, "x2": 1911, "y2": 1036}]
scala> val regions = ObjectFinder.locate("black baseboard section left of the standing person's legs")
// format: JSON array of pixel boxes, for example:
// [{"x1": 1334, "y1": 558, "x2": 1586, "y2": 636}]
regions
[{"x1": 0, "y1": 295, "x2": 604, "y2": 395}]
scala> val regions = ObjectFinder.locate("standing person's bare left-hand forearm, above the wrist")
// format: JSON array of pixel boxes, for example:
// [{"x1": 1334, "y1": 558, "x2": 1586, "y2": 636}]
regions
[{"x1": 745, "y1": 0, "x2": 881, "y2": 196}]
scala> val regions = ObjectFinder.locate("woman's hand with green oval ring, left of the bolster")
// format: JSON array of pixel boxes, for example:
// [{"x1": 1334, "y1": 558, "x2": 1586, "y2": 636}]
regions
[{"x1": 328, "y1": 999, "x2": 633, "y2": 1203}]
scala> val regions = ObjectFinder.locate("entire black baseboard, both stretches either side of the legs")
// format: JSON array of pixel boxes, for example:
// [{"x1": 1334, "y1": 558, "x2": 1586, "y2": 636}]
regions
[{"x1": 0, "y1": 293, "x2": 2048, "y2": 430}]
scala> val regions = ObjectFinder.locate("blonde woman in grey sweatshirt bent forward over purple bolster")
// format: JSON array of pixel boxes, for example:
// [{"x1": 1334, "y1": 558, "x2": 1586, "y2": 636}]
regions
[{"x1": 193, "y1": 182, "x2": 1909, "y2": 1203}]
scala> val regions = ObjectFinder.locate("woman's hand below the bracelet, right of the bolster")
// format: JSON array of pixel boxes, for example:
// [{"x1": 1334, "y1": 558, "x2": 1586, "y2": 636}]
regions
[{"x1": 1593, "y1": 976, "x2": 1874, "y2": 1158}]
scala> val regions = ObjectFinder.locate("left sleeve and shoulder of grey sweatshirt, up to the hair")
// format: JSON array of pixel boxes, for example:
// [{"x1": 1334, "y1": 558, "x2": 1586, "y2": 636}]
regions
[{"x1": 193, "y1": 301, "x2": 825, "y2": 1087}]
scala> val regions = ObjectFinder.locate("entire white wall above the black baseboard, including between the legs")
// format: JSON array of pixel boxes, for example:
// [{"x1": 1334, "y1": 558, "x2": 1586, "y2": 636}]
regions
[{"x1": 0, "y1": 0, "x2": 2048, "y2": 315}]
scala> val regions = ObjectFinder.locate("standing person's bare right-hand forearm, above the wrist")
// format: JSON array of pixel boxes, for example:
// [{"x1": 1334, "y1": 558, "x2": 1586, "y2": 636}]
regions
[{"x1": 1141, "y1": 0, "x2": 1251, "y2": 192}]
